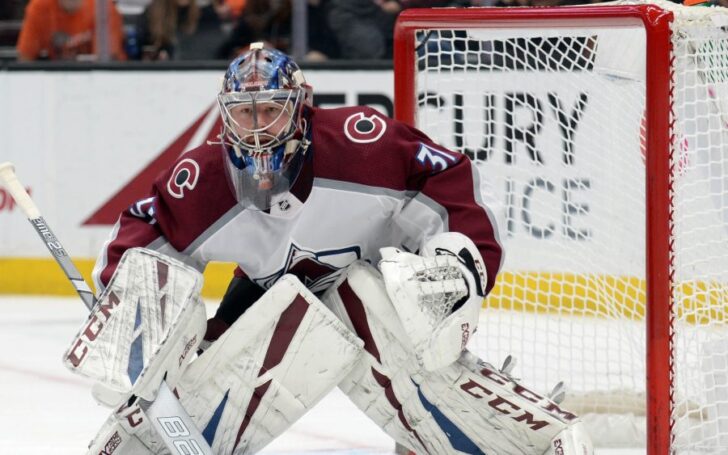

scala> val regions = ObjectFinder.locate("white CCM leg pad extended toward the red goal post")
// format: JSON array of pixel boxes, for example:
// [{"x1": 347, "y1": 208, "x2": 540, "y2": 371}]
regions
[{"x1": 323, "y1": 262, "x2": 593, "y2": 455}]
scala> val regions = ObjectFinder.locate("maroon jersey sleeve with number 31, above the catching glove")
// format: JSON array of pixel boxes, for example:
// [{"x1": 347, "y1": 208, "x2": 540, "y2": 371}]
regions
[{"x1": 312, "y1": 106, "x2": 503, "y2": 292}]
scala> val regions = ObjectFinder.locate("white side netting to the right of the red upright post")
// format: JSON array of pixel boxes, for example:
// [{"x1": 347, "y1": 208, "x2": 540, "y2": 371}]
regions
[{"x1": 673, "y1": 6, "x2": 728, "y2": 453}]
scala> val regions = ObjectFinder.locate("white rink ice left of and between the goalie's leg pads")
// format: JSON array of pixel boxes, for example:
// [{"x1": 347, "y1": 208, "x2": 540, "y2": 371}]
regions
[{"x1": 0, "y1": 296, "x2": 645, "y2": 455}]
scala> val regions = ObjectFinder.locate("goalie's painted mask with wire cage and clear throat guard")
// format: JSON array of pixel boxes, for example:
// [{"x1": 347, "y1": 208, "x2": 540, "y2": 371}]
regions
[{"x1": 217, "y1": 43, "x2": 312, "y2": 210}]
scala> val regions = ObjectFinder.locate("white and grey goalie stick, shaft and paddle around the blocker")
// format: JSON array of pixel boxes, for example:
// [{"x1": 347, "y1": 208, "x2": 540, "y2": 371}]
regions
[{"x1": 0, "y1": 162, "x2": 212, "y2": 455}]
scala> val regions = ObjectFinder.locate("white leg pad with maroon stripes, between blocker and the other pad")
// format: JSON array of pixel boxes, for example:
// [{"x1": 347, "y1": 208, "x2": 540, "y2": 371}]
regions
[{"x1": 171, "y1": 275, "x2": 363, "y2": 454}]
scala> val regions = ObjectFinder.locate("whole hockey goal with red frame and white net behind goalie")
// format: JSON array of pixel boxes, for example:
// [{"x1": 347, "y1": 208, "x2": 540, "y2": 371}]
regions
[{"x1": 395, "y1": 1, "x2": 728, "y2": 454}]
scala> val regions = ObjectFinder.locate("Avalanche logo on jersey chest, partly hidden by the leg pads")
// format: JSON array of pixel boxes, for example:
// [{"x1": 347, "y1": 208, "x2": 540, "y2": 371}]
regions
[{"x1": 253, "y1": 244, "x2": 361, "y2": 293}]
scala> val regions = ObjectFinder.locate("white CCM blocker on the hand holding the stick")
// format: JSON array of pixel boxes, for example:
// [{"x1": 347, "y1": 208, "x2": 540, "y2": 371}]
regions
[{"x1": 63, "y1": 248, "x2": 206, "y2": 407}]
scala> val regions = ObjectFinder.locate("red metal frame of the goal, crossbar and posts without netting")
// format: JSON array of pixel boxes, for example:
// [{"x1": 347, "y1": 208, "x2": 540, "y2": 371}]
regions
[{"x1": 394, "y1": 5, "x2": 674, "y2": 455}]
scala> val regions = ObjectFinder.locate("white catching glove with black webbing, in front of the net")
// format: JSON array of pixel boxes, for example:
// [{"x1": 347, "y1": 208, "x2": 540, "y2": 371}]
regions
[{"x1": 379, "y1": 232, "x2": 487, "y2": 371}]
